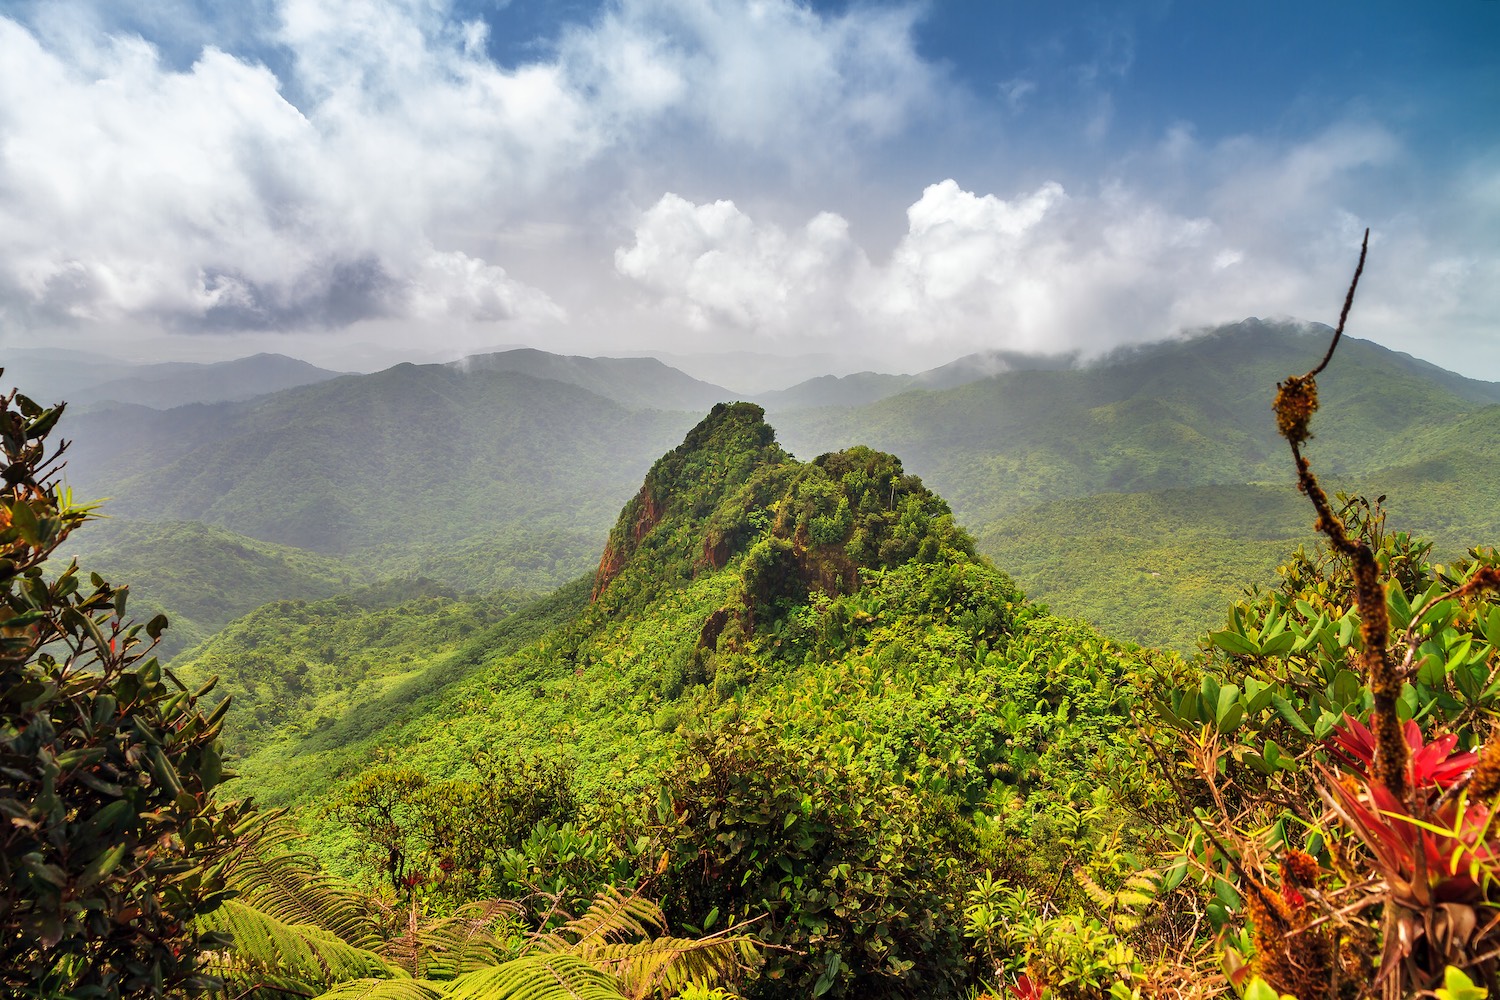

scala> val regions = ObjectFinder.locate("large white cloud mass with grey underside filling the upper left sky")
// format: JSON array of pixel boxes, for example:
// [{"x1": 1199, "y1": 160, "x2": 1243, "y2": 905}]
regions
[{"x1": 0, "y1": 0, "x2": 933, "y2": 330}]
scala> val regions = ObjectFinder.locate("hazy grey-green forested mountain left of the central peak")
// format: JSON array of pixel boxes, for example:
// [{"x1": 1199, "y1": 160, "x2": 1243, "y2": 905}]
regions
[{"x1": 68, "y1": 364, "x2": 705, "y2": 585}]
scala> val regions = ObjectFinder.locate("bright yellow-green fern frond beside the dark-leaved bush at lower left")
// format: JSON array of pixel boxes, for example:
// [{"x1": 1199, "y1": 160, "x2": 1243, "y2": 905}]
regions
[{"x1": 195, "y1": 900, "x2": 395, "y2": 994}]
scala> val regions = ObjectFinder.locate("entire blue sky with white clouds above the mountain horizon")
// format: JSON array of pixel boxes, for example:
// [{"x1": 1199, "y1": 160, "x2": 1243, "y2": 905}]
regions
[{"x1": 0, "y1": 0, "x2": 1500, "y2": 379}]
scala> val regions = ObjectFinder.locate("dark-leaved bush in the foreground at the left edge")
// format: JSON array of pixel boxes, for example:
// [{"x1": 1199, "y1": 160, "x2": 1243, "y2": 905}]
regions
[{"x1": 0, "y1": 377, "x2": 249, "y2": 999}]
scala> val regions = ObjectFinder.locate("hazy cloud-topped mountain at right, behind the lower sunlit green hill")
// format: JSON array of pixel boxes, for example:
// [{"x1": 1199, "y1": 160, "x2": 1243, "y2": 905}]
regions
[{"x1": 773, "y1": 321, "x2": 1500, "y2": 526}]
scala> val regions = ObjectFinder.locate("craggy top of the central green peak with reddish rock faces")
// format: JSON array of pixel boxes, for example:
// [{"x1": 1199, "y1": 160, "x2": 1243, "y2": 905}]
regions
[{"x1": 594, "y1": 403, "x2": 974, "y2": 643}]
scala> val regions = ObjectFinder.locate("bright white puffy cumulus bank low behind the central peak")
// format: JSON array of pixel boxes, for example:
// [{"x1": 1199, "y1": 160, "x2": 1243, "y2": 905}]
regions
[{"x1": 615, "y1": 180, "x2": 1214, "y2": 351}]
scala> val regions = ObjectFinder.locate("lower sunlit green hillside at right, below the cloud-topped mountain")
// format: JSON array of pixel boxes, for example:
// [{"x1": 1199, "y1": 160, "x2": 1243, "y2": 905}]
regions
[{"x1": 978, "y1": 406, "x2": 1500, "y2": 651}]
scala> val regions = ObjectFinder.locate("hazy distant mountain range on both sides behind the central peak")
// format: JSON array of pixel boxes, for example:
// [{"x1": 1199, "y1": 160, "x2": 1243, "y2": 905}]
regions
[{"x1": 41, "y1": 319, "x2": 1500, "y2": 645}]
